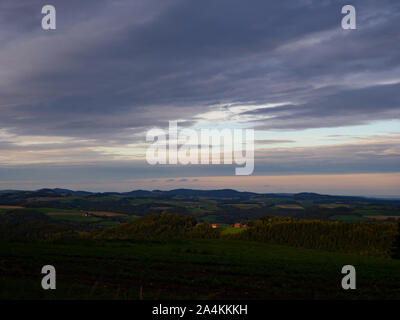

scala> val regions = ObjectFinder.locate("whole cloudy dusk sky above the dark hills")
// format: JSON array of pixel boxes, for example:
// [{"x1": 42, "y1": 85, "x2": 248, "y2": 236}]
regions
[{"x1": 0, "y1": 0, "x2": 400, "y2": 197}]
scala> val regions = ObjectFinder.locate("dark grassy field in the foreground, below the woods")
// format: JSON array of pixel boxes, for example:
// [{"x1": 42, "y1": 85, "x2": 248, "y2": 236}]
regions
[{"x1": 0, "y1": 240, "x2": 400, "y2": 300}]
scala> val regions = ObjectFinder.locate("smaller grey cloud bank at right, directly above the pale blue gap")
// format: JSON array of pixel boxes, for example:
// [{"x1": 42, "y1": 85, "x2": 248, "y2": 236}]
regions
[{"x1": 243, "y1": 84, "x2": 400, "y2": 129}]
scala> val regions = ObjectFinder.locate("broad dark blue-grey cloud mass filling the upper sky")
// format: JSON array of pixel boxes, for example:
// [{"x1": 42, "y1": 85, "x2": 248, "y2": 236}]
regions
[{"x1": 0, "y1": 0, "x2": 400, "y2": 140}]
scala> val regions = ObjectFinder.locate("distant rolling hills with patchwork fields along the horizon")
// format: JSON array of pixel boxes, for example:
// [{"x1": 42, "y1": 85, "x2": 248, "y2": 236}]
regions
[{"x1": 0, "y1": 189, "x2": 400, "y2": 224}]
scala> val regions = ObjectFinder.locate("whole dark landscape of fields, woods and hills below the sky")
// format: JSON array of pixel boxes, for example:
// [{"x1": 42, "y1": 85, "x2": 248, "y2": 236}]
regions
[{"x1": 0, "y1": 190, "x2": 400, "y2": 300}]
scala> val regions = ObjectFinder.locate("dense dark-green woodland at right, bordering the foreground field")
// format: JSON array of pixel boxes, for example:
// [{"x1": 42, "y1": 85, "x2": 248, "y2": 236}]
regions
[{"x1": 224, "y1": 217, "x2": 400, "y2": 257}]
